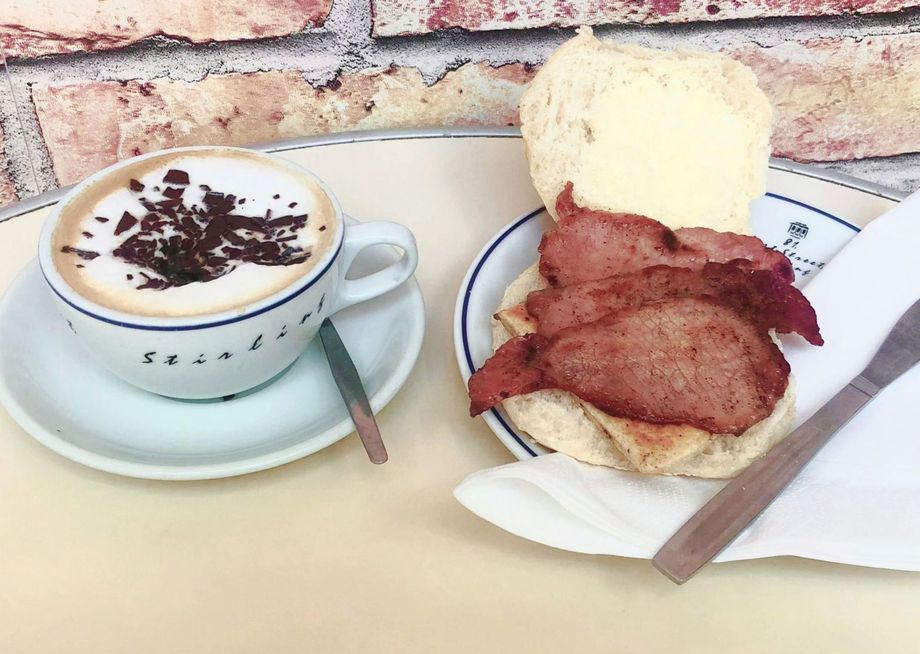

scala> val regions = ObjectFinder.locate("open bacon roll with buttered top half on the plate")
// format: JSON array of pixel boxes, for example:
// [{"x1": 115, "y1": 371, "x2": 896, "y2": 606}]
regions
[{"x1": 469, "y1": 31, "x2": 823, "y2": 478}]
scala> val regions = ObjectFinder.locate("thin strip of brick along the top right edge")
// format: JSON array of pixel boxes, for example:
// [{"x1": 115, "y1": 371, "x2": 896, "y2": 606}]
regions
[{"x1": 372, "y1": 0, "x2": 920, "y2": 36}]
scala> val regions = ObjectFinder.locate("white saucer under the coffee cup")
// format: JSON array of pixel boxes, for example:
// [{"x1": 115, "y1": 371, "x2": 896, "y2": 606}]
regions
[{"x1": 0, "y1": 251, "x2": 425, "y2": 479}]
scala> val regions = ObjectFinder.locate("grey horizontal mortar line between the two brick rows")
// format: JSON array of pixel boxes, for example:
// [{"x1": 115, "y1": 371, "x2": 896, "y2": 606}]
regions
[{"x1": 5, "y1": 2, "x2": 920, "y2": 83}]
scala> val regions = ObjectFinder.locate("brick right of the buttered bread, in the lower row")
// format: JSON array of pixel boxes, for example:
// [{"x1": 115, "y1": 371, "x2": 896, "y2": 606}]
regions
[{"x1": 728, "y1": 34, "x2": 920, "y2": 161}]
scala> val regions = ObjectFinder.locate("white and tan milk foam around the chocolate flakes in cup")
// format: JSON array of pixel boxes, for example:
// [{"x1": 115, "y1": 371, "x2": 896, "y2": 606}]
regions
[{"x1": 54, "y1": 151, "x2": 338, "y2": 316}]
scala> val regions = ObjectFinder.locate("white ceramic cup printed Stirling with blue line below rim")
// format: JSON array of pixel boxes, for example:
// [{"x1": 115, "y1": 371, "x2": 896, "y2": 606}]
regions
[{"x1": 39, "y1": 146, "x2": 418, "y2": 399}]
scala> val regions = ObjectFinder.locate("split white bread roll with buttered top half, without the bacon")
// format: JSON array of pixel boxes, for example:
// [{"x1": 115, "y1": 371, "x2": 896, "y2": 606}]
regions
[{"x1": 492, "y1": 28, "x2": 795, "y2": 478}]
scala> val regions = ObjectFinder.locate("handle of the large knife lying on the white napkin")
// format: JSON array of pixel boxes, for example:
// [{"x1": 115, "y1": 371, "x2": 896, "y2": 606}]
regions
[{"x1": 652, "y1": 377, "x2": 878, "y2": 584}]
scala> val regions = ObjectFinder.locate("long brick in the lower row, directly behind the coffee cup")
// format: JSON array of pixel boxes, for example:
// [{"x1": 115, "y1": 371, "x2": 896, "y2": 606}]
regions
[{"x1": 32, "y1": 63, "x2": 533, "y2": 184}]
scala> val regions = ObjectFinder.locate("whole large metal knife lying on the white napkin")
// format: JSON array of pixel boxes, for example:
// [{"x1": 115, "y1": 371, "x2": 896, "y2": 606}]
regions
[{"x1": 652, "y1": 300, "x2": 920, "y2": 584}]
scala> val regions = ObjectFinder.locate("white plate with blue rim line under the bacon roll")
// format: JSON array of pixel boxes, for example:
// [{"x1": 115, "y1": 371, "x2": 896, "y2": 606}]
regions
[{"x1": 454, "y1": 193, "x2": 859, "y2": 459}]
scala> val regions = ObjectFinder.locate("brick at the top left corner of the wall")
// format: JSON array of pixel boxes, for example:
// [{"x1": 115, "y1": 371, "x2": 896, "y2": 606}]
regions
[{"x1": 0, "y1": 0, "x2": 332, "y2": 58}]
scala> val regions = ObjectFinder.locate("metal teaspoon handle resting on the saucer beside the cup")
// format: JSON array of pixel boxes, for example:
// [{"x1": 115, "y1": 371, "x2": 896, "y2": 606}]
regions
[{"x1": 319, "y1": 318, "x2": 388, "y2": 463}]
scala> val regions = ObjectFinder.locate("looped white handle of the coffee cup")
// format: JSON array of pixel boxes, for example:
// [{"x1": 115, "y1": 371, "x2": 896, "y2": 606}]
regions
[{"x1": 332, "y1": 220, "x2": 418, "y2": 313}]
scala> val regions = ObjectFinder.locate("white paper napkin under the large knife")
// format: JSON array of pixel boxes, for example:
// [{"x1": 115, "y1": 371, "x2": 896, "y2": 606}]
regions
[{"x1": 454, "y1": 193, "x2": 920, "y2": 571}]
